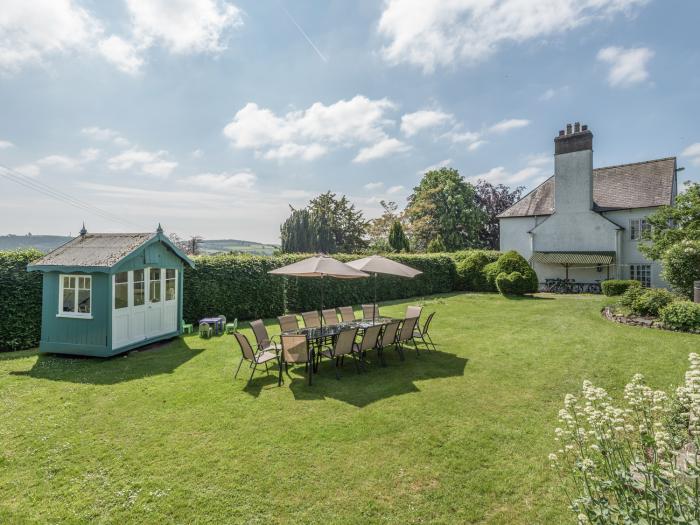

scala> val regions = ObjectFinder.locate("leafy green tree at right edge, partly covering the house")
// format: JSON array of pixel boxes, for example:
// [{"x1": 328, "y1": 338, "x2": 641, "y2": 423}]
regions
[{"x1": 639, "y1": 182, "x2": 700, "y2": 260}]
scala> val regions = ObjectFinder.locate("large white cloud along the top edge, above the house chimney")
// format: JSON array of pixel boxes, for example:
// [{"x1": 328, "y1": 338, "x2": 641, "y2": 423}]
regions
[{"x1": 378, "y1": 0, "x2": 647, "y2": 73}]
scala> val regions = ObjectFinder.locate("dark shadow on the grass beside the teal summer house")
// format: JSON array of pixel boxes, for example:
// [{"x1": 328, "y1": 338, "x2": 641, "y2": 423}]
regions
[{"x1": 10, "y1": 338, "x2": 203, "y2": 385}]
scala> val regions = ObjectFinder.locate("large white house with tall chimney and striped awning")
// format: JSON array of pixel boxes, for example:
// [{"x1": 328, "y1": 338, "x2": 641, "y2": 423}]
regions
[{"x1": 498, "y1": 122, "x2": 677, "y2": 287}]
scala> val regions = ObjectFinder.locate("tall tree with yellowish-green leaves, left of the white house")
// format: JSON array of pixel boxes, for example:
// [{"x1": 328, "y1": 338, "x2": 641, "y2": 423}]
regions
[{"x1": 405, "y1": 168, "x2": 486, "y2": 251}]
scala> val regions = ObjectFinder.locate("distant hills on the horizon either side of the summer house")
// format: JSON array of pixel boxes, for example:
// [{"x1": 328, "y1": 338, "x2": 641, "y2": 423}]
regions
[{"x1": 0, "y1": 235, "x2": 279, "y2": 255}]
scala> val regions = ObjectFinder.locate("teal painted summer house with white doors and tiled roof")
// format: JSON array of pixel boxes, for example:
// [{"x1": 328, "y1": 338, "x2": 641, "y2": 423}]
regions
[{"x1": 27, "y1": 226, "x2": 194, "y2": 357}]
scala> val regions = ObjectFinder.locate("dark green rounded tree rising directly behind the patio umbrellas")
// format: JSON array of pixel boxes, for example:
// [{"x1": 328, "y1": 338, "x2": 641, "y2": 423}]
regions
[{"x1": 280, "y1": 191, "x2": 367, "y2": 253}]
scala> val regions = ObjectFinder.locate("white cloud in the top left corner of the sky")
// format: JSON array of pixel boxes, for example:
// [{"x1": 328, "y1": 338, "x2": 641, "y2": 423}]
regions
[{"x1": 0, "y1": 0, "x2": 102, "y2": 73}]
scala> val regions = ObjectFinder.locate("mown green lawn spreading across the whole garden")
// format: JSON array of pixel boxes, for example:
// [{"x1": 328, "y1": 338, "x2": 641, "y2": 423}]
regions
[{"x1": 0, "y1": 294, "x2": 700, "y2": 524}]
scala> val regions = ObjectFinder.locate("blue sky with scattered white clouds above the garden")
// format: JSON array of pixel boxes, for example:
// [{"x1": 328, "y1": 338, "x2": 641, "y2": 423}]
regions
[{"x1": 0, "y1": 0, "x2": 700, "y2": 243}]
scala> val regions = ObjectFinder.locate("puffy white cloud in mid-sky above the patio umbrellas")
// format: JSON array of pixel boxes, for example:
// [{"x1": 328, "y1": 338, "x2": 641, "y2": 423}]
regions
[{"x1": 223, "y1": 95, "x2": 398, "y2": 160}]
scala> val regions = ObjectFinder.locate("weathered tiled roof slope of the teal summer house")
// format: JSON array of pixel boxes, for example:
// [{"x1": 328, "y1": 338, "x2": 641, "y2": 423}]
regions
[{"x1": 30, "y1": 233, "x2": 157, "y2": 268}]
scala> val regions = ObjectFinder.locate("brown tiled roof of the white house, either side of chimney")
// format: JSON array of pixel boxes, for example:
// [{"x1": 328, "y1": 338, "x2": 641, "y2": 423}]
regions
[{"x1": 499, "y1": 157, "x2": 676, "y2": 217}]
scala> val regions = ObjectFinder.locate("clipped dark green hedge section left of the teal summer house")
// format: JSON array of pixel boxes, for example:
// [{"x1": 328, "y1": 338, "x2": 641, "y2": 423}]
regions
[{"x1": 0, "y1": 249, "x2": 42, "y2": 351}]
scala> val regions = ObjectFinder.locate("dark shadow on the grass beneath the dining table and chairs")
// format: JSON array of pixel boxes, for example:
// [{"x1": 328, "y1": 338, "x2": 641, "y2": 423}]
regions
[{"x1": 276, "y1": 349, "x2": 469, "y2": 407}]
